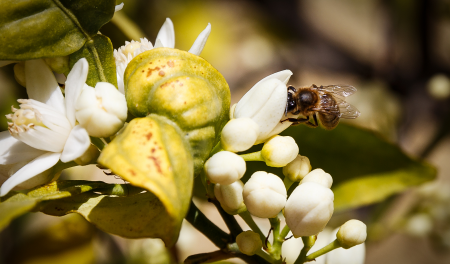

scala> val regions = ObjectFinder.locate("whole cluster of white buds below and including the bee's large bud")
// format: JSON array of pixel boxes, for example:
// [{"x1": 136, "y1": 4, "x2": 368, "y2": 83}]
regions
[{"x1": 205, "y1": 70, "x2": 366, "y2": 257}]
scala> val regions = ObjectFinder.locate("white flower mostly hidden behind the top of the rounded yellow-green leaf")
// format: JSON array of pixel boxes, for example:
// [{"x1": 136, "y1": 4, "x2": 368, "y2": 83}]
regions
[{"x1": 114, "y1": 18, "x2": 211, "y2": 93}]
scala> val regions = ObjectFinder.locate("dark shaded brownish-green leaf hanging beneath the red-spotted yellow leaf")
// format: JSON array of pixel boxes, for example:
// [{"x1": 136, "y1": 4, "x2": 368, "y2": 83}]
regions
[{"x1": 42, "y1": 192, "x2": 182, "y2": 246}]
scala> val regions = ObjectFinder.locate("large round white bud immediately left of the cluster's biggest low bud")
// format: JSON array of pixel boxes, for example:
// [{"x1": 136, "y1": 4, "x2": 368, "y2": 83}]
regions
[{"x1": 242, "y1": 171, "x2": 287, "y2": 218}]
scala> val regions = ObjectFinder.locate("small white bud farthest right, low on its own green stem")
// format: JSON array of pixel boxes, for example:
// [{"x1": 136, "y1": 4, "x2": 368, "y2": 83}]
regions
[{"x1": 336, "y1": 219, "x2": 367, "y2": 249}]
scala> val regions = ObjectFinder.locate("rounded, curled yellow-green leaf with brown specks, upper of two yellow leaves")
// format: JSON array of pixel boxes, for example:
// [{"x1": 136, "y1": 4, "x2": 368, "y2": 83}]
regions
[{"x1": 124, "y1": 48, "x2": 230, "y2": 172}]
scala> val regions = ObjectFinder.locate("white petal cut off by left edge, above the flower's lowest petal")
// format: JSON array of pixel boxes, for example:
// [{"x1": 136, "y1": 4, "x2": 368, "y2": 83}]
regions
[{"x1": 0, "y1": 131, "x2": 45, "y2": 165}]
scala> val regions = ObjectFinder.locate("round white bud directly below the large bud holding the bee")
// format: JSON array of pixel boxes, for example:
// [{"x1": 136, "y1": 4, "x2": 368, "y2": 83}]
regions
[{"x1": 220, "y1": 117, "x2": 259, "y2": 152}]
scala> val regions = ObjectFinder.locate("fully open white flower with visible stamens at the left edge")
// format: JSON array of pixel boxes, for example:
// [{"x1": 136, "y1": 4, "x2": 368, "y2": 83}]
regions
[{"x1": 0, "y1": 59, "x2": 90, "y2": 196}]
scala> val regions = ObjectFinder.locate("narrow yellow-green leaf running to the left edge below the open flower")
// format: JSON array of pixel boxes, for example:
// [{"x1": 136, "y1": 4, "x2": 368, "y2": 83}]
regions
[{"x1": 0, "y1": 181, "x2": 115, "y2": 230}]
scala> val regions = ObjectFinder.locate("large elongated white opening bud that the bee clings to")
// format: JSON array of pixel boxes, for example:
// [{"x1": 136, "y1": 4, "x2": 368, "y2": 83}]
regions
[{"x1": 230, "y1": 70, "x2": 292, "y2": 144}]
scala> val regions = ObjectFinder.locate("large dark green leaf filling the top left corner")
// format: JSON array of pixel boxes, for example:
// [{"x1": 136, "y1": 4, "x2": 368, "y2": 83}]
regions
[{"x1": 0, "y1": 0, "x2": 115, "y2": 60}]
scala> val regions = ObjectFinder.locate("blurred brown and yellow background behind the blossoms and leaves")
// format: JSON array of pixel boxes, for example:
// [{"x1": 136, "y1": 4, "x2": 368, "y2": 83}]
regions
[{"x1": 0, "y1": 0, "x2": 450, "y2": 264}]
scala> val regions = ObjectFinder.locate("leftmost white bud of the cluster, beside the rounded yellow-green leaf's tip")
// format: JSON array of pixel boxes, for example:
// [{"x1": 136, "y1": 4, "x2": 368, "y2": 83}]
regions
[{"x1": 205, "y1": 151, "x2": 246, "y2": 184}]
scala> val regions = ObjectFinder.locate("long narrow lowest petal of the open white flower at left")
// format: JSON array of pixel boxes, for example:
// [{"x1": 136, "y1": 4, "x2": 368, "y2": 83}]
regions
[{"x1": 0, "y1": 152, "x2": 61, "y2": 196}]
